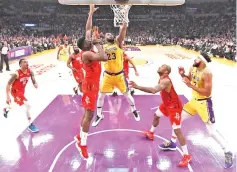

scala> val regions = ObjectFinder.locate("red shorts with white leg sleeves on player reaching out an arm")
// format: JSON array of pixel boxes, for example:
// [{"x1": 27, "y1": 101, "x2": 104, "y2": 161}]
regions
[{"x1": 155, "y1": 104, "x2": 182, "y2": 129}]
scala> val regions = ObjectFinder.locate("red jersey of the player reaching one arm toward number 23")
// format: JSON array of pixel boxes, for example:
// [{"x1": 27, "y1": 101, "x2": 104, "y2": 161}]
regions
[{"x1": 159, "y1": 76, "x2": 182, "y2": 108}]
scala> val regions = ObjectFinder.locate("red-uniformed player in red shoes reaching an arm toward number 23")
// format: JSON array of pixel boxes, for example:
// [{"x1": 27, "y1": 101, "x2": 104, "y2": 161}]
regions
[{"x1": 130, "y1": 65, "x2": 191, "y2": 167}]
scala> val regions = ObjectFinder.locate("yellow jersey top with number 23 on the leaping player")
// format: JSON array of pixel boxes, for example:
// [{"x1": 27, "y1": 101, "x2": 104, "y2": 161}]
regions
[{"x1": 104, "y1": 44, "x2": 123, "y2": 73}]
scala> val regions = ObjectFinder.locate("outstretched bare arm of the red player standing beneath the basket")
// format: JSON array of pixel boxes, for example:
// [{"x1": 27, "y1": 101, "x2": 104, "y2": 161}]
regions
[{"x1": 129, "y1": 79, "x2": 171, "y2": 94}]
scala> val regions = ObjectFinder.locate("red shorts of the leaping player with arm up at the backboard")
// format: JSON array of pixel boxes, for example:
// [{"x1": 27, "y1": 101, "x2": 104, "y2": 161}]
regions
[{"x1": 82, "y1": 81, "x2": 99, "y2": 112}]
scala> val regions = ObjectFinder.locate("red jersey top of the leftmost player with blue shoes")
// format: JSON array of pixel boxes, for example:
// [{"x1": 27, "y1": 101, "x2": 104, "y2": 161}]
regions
[{"x1": 12, "y1": 69, "x2": 31, "y2": 92}]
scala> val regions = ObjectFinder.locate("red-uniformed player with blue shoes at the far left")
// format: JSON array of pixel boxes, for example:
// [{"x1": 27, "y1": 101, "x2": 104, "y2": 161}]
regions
[{"x1": 4, "y1": 59, "x2": 39, "y2": 132}]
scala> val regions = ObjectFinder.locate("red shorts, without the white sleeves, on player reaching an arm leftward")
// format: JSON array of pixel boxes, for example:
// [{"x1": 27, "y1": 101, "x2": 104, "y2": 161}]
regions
[{"x1": 157, "y1": 104, "x2": 183, "y2": 126}]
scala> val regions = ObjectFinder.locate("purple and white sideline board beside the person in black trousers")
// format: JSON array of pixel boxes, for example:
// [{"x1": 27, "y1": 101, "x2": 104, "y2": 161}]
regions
[{"x1": 8, "y1": 46, "x2": 32, "y2": 60}]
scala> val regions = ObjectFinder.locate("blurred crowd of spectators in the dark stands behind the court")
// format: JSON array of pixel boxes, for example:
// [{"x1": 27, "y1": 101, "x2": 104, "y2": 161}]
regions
[{"x1": 0, "y1": 0, "x2": 236, "y2": 61}]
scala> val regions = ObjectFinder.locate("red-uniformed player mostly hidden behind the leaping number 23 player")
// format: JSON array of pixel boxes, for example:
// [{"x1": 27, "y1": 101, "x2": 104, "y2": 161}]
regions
[{"x1": 112, "y1": 52, "x2": 139, "y2": 96}]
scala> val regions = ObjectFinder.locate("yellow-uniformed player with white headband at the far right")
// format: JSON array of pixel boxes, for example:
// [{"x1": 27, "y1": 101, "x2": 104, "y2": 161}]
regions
[{"x1": 160, "y1": 53, "x2": 233, "y2": 168}]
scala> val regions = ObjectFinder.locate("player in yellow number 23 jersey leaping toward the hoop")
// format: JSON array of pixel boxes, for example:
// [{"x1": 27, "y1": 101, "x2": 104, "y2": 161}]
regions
[{"x1": 92, "y1": 24, "x2": 140, "y2": 127}]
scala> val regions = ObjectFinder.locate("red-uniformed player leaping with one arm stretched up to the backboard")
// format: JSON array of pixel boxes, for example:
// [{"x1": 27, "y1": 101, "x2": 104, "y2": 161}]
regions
[{"x1": 74, "y1": 5, "x2": 108, "y2": 159}]
